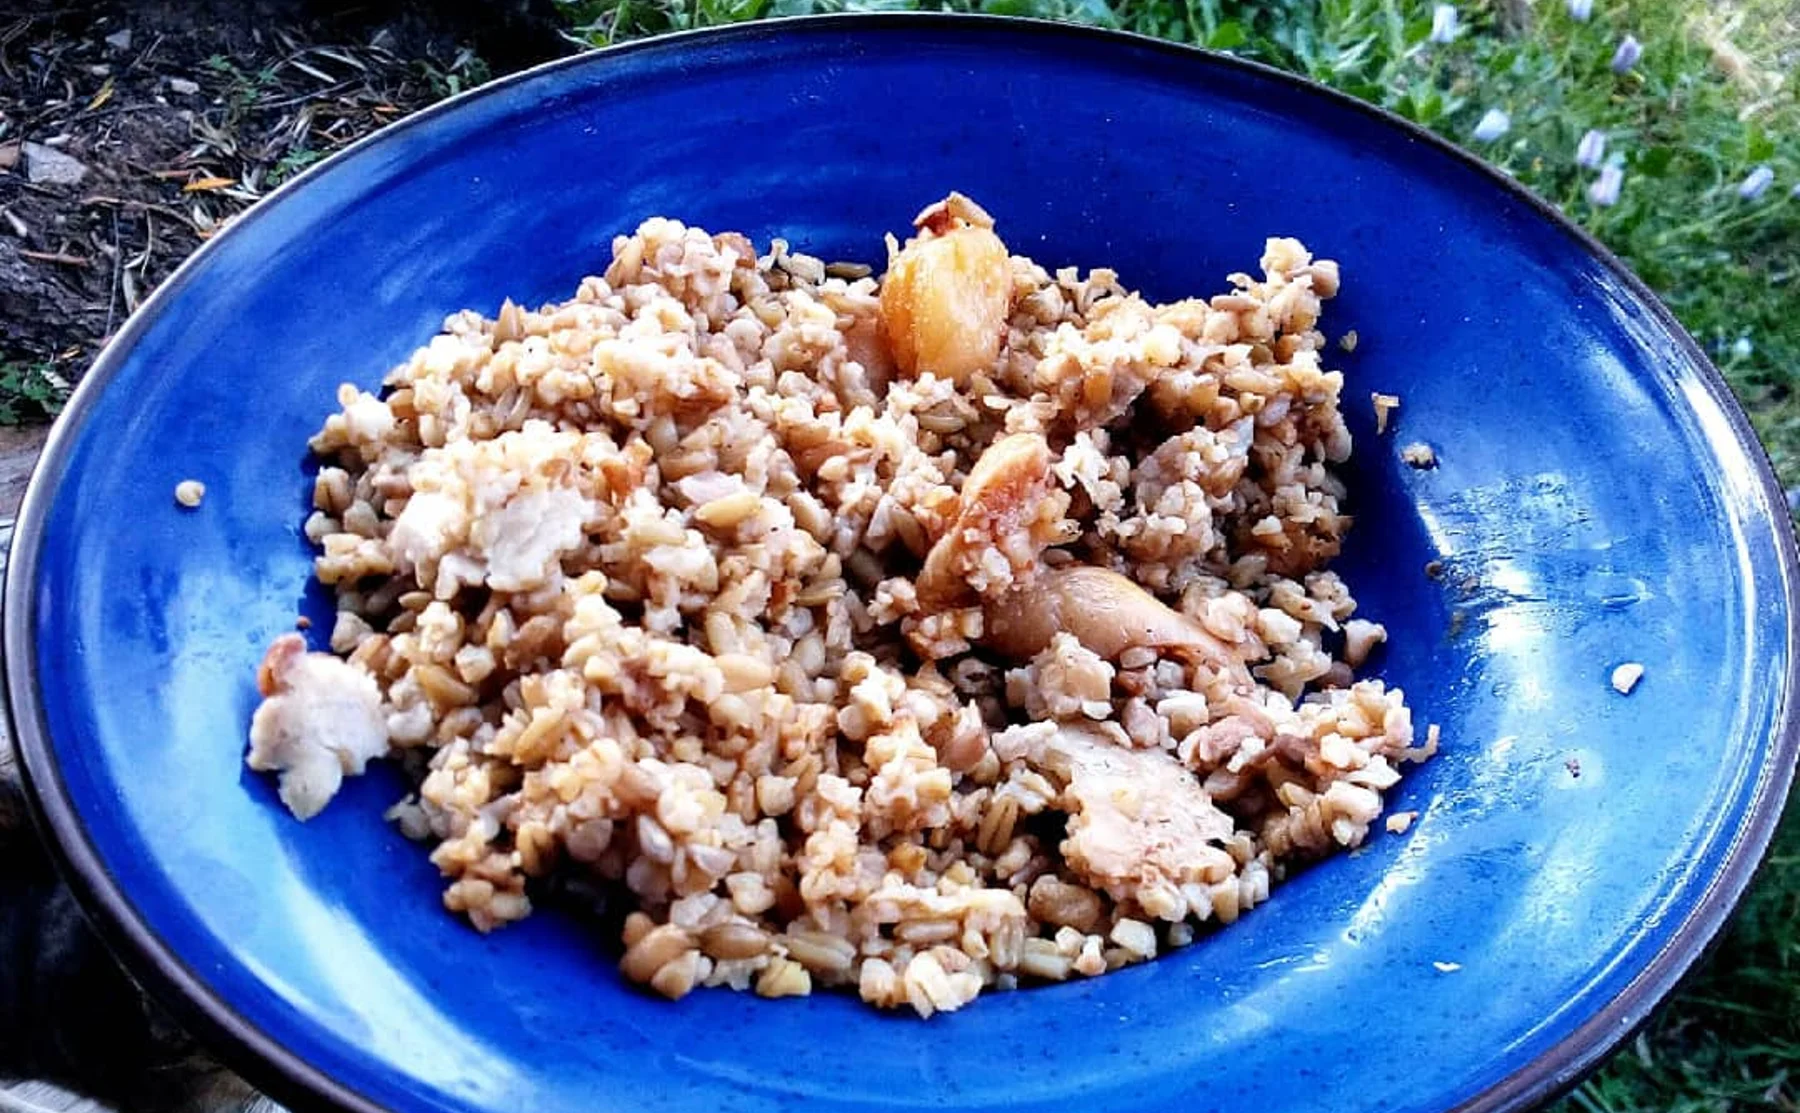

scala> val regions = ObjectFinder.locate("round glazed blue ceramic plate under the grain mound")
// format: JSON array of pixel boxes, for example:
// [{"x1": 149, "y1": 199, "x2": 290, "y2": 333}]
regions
[{"x1": 5, "y1": 18, "x2": 1796, "y2": 1113}]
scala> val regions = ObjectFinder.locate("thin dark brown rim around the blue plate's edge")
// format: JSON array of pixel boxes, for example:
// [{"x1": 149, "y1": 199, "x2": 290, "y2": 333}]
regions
[{"x1": 4, "y1": 13, "x2": 1800, "y2": 1113}]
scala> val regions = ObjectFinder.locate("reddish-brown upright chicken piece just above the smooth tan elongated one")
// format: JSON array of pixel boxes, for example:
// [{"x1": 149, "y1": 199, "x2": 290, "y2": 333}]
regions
[{"x1": 914, "y1": 432, "x2": 1067, "y2": 605}]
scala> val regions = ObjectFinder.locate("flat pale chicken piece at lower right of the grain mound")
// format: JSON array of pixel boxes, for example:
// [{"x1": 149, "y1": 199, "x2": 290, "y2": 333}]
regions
[{"x1": 1044, "y1": 726, "x2": 1233, "y2": 918}]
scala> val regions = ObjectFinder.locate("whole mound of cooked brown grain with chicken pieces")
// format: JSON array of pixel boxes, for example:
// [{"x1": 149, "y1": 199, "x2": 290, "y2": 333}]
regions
[{"x1": 248, "y1": 195, "x2": 1436, "y2": 1016}]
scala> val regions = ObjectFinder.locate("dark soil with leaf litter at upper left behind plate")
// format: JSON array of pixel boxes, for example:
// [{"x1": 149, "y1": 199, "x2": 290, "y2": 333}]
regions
[{"x1": 0, "y1": 0, "x2": 574, "y2": 423}]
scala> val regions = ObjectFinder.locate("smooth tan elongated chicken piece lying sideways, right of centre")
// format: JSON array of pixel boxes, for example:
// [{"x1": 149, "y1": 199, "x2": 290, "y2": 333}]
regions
[{"x1": 981, "y1": 566, "x2": 1242, "y2": 672}]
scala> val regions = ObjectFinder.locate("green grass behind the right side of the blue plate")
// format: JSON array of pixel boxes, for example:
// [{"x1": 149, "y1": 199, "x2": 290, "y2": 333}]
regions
[{"x1": 565, "y1": 0, "x2": 1800, "y2": 1113}]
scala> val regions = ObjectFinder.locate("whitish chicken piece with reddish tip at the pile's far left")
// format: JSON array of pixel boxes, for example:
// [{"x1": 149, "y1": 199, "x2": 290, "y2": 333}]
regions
[{"x1": 247, "y1": 634, "x2": 387, "y2": 819}]
